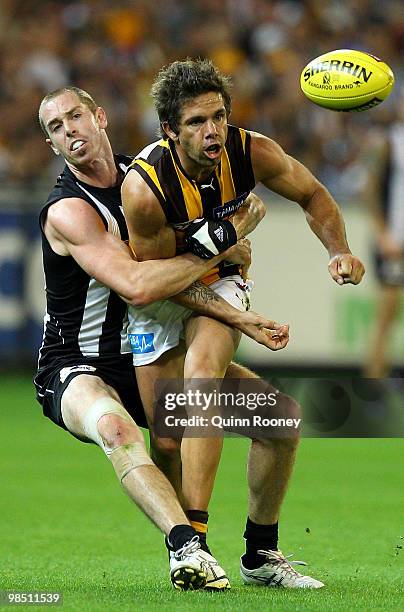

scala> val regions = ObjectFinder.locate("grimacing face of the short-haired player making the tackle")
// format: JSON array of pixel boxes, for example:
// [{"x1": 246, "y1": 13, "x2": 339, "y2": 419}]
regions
[{"x1": 41, "y1": 92, "x2": 107, "y2": 166}]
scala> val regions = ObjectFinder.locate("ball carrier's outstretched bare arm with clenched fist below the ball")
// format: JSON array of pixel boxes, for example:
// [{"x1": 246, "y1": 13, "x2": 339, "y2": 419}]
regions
[{"x1": 251, "y1": 132, "x2": 365, "y2": 285}]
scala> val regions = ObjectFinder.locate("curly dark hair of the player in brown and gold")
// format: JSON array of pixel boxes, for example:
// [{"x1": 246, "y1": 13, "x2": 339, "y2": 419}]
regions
[{"x1": 151, "y1": 58, "x2": 231, "y2": 138}]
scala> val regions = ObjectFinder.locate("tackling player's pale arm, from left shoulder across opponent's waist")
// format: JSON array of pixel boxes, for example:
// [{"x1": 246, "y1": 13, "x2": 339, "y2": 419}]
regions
[{"x1": 45, "y1": 198, "x2": 240, "y2": 306}]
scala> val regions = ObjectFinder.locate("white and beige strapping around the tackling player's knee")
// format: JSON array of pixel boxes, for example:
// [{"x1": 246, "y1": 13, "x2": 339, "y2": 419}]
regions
[{"x1": 83, "y1": 397, "x2": 154, "y2": 482}]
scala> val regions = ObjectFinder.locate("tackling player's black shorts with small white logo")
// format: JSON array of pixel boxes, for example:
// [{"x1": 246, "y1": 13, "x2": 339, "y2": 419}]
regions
[{"x1": 34, "y1": 354, "x2": 148, "y2": 430}]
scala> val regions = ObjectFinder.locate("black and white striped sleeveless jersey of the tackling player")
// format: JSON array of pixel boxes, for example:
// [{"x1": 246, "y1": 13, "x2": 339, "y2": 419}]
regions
[{"x1": 34, "y1": 155, "x2": 133, "y2": 399}]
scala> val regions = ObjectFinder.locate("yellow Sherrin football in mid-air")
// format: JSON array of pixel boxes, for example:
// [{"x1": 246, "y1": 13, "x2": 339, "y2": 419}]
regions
[{"x1": 300, "y1": 49, "x2": 394, "y2": 112}]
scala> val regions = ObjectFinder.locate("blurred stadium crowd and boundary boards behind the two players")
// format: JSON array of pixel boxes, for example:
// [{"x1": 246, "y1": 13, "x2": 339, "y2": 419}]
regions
[{"x1": 0, "y1": 0, "x2": 404, "y2": 368}]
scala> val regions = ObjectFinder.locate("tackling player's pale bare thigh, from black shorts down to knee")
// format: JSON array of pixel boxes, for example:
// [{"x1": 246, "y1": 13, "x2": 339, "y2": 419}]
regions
[{"x1": 61, "y1": 374, "x2": 122, "y2": 439}]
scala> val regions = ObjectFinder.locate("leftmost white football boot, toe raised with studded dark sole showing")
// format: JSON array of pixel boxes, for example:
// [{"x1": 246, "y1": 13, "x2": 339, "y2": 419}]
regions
[{"x1": 169, "y1": 536, "x2": 207, "y2": 591}]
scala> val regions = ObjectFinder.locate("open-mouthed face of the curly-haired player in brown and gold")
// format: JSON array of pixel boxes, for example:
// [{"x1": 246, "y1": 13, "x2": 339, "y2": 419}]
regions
[{"x1": 174, "y1": 92, "x2": 227, "y2": 173}]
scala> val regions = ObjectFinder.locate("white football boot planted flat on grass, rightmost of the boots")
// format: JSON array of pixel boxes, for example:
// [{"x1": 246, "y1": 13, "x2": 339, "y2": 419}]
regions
[{"x1": 240, "y1": 550, "x2": 324, "y2": 589}]
